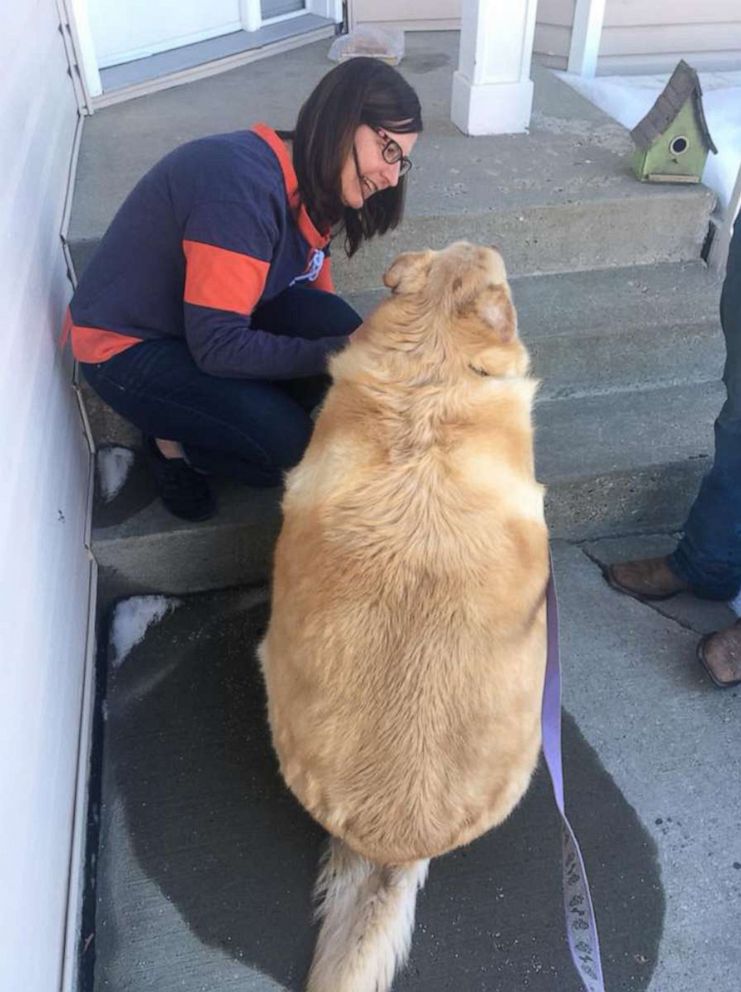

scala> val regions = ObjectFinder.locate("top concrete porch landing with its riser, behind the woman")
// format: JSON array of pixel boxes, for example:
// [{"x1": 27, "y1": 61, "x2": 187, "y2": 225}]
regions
[{"x1": 68, "y1": 32, "x2": 714, "y2": 294}]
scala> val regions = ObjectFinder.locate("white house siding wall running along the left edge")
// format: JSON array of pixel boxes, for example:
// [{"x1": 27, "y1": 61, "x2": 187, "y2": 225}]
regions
[{"x1": 0, "y1": 0, "x2": 90, "y2": 992}]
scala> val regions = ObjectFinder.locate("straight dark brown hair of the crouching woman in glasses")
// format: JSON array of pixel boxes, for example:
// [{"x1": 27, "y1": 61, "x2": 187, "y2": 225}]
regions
[{"x1": 278, "y1": 58, "x2": 422, "y2": 255}]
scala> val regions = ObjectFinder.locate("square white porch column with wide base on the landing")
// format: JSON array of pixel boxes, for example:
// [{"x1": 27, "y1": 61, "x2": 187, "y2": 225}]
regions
[{"x1": 450, "y1": 0, "x2": 537, "y2": 134}]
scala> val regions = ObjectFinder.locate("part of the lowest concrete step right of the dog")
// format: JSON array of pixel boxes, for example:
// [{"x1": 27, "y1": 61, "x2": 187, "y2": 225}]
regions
[{"x1": 535, "y1": 382, "x2": 725, "y2": 541}]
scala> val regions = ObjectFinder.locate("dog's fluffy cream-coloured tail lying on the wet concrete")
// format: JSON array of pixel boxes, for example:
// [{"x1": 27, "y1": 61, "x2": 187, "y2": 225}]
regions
[{"x1": 307, "y1": 838, "x2": 429, "y2": 992}]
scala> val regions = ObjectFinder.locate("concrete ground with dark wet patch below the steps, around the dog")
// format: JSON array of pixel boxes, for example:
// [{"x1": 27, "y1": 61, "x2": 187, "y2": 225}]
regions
[{"x1": 88, "y1": 537, "x2": 741, "y2": 992}]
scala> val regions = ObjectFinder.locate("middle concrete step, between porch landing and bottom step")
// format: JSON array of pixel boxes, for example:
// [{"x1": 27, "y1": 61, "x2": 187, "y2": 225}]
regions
[{"x1": 82, "y1": 262, "x2": 724, "y2": 447}]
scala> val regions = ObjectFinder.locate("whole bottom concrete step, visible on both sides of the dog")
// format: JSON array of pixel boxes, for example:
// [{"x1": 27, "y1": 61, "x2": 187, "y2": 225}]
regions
[{"x1": 93, "y1": 383, "x2": 723, "y2": 601}]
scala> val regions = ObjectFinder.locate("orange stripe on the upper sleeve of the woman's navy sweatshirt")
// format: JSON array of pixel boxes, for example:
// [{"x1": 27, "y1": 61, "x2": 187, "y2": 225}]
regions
[{"x1": 183, "y1": 241, "x2": 270, "y2": 314}]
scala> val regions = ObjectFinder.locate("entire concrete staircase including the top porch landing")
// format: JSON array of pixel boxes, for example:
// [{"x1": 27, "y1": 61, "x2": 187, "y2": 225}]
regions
[{"x1": 70, "y1": 33, "x2": 723, "y2": 599}]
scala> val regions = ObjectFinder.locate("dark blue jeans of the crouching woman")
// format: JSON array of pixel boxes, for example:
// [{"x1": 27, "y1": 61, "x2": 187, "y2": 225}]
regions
[{"x1": 80, "y1": 286, "x2": 361, "y2": 486}]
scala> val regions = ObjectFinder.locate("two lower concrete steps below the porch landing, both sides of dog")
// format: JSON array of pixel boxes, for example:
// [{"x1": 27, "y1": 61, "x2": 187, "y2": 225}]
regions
[{"x1": 91, "y1": 262, "x2": 723, "y2": 597}]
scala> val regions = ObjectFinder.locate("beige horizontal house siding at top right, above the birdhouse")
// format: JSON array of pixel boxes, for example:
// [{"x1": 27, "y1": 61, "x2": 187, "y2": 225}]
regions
[{"x1": 597, "y1": 0, "x2": 741, "y2": 75}]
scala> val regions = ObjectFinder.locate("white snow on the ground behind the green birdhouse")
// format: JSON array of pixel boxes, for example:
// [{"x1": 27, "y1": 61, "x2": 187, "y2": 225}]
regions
[{"x1": 557, "y1": 71, "x2": 741, "y2": 217}]
